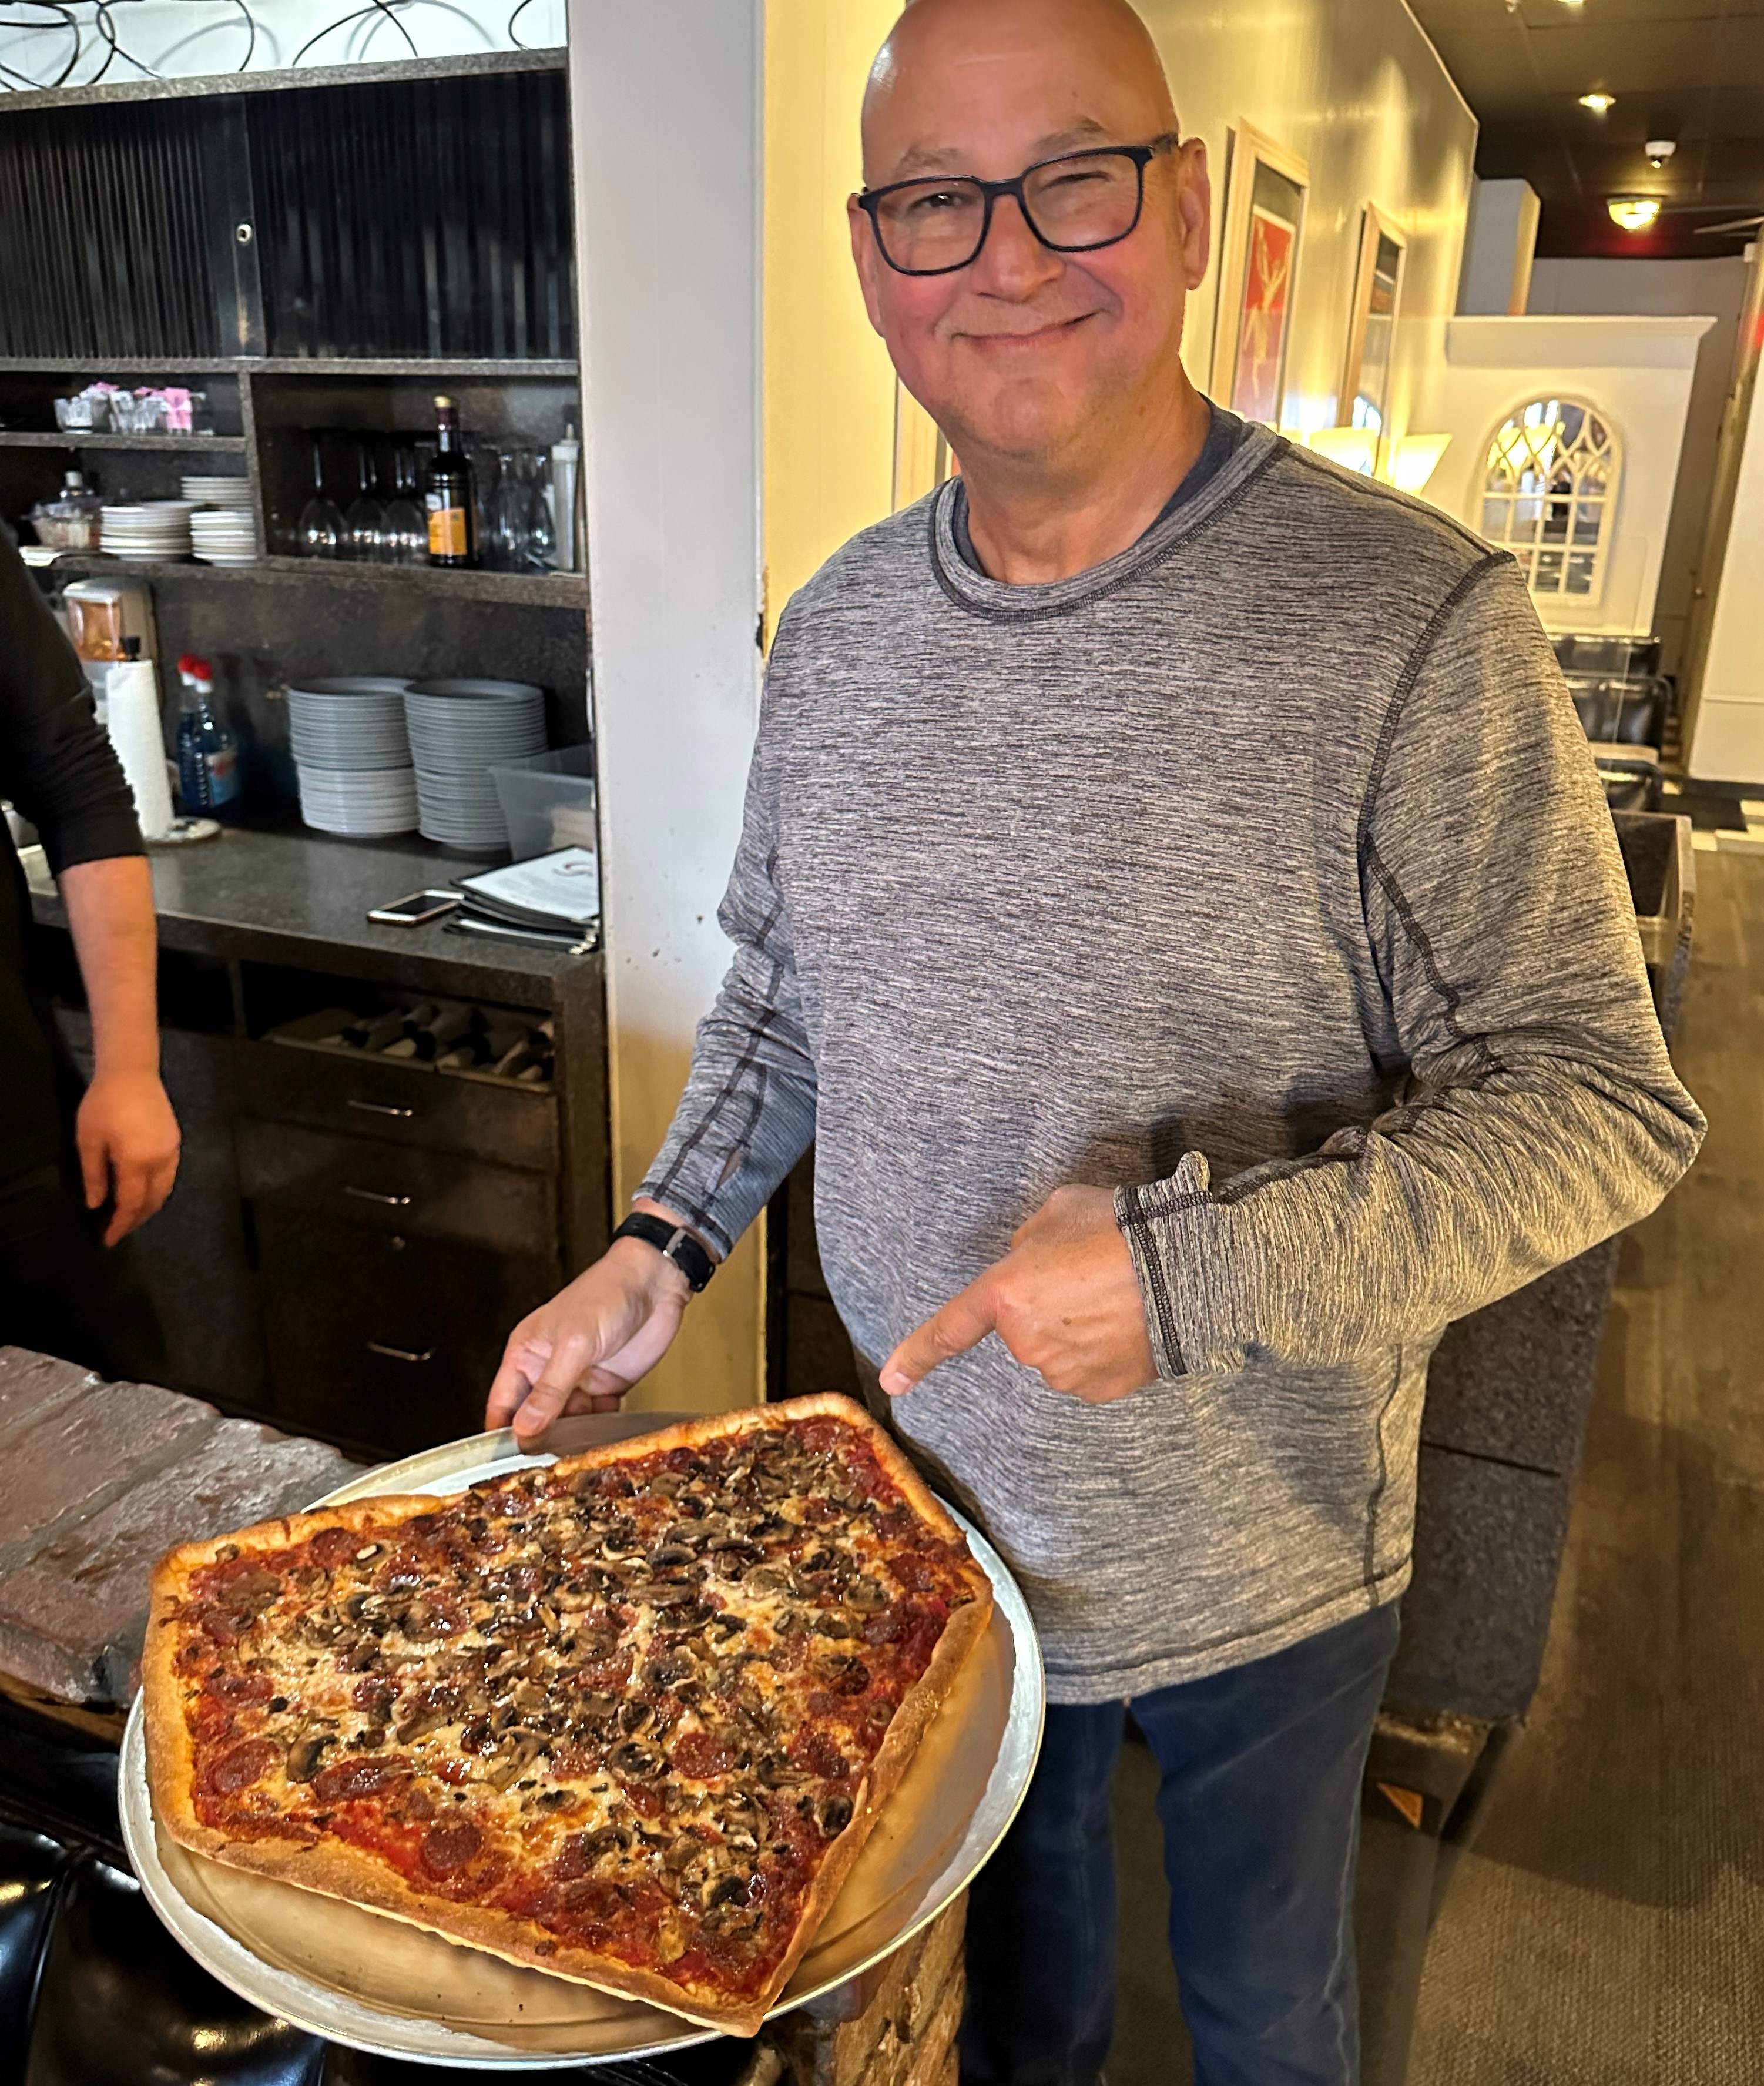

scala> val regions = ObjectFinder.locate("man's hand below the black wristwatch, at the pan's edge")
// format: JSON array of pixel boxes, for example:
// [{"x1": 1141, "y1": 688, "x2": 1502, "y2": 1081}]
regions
[{"x1": 484, "y1": 1239, "x2": 692, "y2": 1445}]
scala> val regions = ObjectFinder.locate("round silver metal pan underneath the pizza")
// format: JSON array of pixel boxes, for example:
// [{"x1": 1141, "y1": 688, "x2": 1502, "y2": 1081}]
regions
[{"x1": 119, "y1": 1412, "x2": 1045, "y2": 2071}]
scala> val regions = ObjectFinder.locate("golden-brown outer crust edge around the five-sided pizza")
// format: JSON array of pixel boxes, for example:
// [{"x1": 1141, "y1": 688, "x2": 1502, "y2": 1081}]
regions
[{"x1": 142, "y1": 1391, "x2": 992, "y2": 2036}]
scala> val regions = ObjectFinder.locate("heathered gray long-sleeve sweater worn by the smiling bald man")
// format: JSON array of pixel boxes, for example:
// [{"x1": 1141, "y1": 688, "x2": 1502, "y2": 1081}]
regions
[{"x1": 646, "y1": 430, "x2": 1702, "y2": 1702}]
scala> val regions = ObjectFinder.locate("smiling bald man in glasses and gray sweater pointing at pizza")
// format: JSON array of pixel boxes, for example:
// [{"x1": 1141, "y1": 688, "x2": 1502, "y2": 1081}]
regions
[{"x1": 490, "y1": 0, "x2": 1702, "y2": 2086}]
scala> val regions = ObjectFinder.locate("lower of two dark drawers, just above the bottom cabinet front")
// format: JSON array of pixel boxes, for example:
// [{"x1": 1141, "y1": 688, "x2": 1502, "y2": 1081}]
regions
[{"x1": 233, "y1": 1116, "x2": 556, "y2": 1260}]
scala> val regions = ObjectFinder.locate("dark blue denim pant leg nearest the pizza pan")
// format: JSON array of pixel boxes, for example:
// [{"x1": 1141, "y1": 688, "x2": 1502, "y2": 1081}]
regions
[{"x1": 961, "y1": 1702, "x2": 1126, "y2": 2086}]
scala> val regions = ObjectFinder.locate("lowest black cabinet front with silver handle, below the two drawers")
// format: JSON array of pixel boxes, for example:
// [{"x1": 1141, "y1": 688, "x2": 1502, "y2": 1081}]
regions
[{"x1": 252, "y1": 1201, "x2": 556, "y2": 1456}]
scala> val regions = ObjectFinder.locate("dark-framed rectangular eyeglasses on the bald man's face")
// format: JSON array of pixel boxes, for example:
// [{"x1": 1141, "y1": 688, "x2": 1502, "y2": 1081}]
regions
[{"x1": 857, "y1": 132, "x2": 1180, "y2": 275}]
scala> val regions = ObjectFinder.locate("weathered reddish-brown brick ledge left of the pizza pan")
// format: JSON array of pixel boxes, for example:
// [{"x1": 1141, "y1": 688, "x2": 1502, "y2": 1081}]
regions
[{"x1": 0, "y1": 1348, "x2": 358, "y2": 1715}]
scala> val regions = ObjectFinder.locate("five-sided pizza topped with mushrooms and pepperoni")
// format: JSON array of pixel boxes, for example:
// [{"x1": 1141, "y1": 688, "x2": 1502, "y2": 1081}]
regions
[{"x1": 142, "y1": 1395, "x2": 992, "y2": 2034}]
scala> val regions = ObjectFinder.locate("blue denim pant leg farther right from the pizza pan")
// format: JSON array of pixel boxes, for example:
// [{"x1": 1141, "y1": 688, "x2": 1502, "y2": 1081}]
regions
[{"x1": 1132, "y1": 1604, "x2": 1397, "y2": 2086}]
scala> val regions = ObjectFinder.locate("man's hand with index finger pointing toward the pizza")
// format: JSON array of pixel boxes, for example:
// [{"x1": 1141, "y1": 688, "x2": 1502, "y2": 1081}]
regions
[{"x1": 882, "y1": 1187, "x2": 1157, "y2": 1406}]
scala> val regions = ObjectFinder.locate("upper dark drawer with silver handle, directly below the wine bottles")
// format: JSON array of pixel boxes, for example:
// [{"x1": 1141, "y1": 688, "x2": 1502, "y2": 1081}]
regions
[{"x1": 240, "y1": 1043, "x2": 556, "y2": 1173}]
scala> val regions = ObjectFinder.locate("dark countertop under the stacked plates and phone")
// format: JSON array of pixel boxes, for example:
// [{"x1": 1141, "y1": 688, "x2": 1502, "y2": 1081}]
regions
[{"x1": 29, "y1": 826, "x2": 601, "y2": 1007}]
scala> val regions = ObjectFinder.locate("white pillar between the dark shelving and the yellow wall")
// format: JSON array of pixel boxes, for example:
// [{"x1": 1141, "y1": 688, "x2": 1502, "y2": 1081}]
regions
[{"x1": 569, "y1": 0, "x2": 763, "y2": 1410}]
